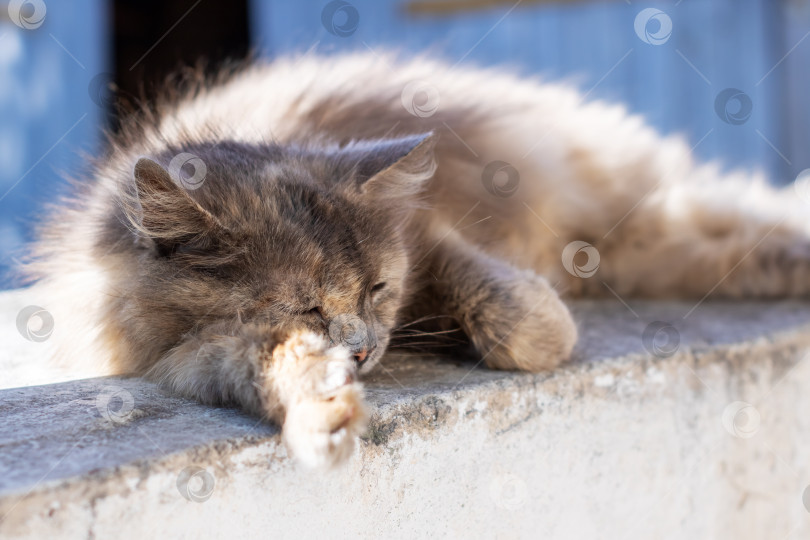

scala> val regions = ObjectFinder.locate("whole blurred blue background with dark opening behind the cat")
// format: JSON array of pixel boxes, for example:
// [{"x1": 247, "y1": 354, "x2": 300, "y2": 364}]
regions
[{"x1": 0, "y1": 0, "x2": 810, "y2": 287}]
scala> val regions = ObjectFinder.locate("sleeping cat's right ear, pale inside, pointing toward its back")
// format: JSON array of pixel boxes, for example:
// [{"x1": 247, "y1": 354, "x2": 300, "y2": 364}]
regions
[{"x1": 344, "y1": 132, "x2": 437, "y2": 201}]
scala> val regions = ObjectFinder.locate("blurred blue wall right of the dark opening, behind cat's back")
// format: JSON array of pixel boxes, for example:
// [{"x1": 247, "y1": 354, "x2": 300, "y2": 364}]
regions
[{"x1": 252, "y1": 0, "x2": 810, "y2": 183}]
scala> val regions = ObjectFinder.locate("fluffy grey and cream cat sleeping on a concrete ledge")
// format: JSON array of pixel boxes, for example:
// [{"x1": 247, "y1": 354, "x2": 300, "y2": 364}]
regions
[{"x1": 19, "y1": 53, "x2": 810, "y2": 467}]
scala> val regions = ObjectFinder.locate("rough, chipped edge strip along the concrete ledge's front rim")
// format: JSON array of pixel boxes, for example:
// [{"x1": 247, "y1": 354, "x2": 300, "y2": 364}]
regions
[{"x1": 0, "y1": 325, "x2": 810, "y2": 526}]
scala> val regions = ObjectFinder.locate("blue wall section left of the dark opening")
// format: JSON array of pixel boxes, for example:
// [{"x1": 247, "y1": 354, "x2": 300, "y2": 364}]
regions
[{"x1": 0, "y1": 0, "x2": 108, "y2": 284}]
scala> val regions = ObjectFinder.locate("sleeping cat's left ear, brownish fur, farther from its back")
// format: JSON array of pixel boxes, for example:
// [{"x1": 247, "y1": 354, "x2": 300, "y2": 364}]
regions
[{"x1": 127, "y1": 157, "x2": 222, "y2": 245}]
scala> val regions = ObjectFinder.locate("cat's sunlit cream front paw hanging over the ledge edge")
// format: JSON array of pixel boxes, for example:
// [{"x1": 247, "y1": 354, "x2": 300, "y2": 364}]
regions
[{"x1": 275, "y1": 332, "x2": 368, "y2": 467}]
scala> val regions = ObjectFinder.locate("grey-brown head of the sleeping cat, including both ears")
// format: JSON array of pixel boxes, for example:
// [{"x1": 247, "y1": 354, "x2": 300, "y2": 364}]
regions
[{"x1": 119, "y1": 134, "x2": 435, "y2": 372}]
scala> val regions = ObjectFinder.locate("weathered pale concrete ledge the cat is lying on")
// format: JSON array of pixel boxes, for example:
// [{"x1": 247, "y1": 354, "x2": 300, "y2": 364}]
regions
[{"x1": 0, "y1": 297, "x2": 810, "y2": 539}]
